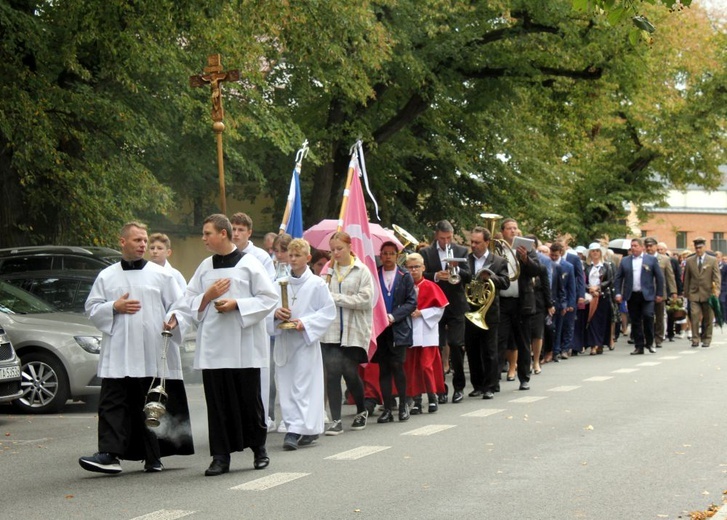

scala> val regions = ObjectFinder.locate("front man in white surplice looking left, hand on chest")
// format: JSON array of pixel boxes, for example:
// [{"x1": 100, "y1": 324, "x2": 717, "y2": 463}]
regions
[{"x1": 183, "y1": 214, "x2": 278, "y2": 476}]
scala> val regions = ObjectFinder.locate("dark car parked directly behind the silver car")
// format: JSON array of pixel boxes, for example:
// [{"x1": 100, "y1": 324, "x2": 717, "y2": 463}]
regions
[{"x1": 0, "y1": 269, "x2": 101, "y2": 314}]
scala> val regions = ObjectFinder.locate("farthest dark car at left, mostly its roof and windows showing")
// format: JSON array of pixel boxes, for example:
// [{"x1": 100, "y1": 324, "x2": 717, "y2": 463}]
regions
[{"x1": 0, "y1": 246, "x2": 121, "y2": 274}]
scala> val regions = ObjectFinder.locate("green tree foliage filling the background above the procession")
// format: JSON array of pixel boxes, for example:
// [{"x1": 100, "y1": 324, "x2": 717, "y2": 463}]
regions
[{"x1": 0, "y1": 0, "x2": 726, "y2": 250}]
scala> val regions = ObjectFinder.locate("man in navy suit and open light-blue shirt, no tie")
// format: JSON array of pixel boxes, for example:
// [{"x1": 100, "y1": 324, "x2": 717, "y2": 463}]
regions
[{"x1": 614, "y1": 238, "x2": 664, "y2": 355}]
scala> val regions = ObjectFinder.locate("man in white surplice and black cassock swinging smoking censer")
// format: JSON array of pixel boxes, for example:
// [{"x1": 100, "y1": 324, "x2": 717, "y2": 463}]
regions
[{"x1": 79, "y1": 222, "x2": 194, "y2": 474}]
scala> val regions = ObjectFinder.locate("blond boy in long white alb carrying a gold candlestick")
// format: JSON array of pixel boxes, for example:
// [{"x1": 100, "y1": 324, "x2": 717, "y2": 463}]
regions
[{"x1": 274, "y1": 238, "x2": 336, "y2": 451}]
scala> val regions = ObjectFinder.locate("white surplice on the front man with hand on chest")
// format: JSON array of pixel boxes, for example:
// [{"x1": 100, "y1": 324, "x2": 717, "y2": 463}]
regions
[{"x1": 184, "y1": 254, "x2": 278, "y2": 370}]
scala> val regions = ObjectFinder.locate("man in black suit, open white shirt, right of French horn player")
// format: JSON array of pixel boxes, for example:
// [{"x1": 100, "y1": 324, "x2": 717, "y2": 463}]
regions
[{"x1": 497, "y1": 218, "x2": 540, "y2": 390}]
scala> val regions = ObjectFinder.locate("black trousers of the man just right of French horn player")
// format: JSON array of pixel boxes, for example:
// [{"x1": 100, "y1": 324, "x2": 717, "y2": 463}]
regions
[{"x1": 497, "y1": 296, "x2": 533, "y2": 383}]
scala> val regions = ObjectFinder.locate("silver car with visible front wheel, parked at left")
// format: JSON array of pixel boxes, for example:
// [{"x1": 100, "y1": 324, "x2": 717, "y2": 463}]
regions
[{"x1": 0, "y1": 282, "x2": 101, "y2": 413}]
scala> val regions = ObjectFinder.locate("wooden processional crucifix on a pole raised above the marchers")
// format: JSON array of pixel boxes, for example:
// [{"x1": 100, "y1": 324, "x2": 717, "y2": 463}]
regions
[{"x1": 189, "y1": 54, "x2": 240, "y2": 215}]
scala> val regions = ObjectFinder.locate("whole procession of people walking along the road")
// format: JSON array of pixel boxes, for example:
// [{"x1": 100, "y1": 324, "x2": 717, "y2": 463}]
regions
[{"x1": 79, "y1": 213, "x2": 727, "y2": 476}]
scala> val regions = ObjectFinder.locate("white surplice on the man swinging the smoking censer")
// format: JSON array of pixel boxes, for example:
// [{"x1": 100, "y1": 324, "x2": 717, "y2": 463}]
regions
[{"x1": 86, "y1": 262, "x2": 188, "y2": 379}]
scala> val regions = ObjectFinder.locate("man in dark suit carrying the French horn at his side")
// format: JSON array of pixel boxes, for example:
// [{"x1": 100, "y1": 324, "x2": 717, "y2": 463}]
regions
[{"x1": 465, "y1": 226, "x2": 510, "y2": 399}]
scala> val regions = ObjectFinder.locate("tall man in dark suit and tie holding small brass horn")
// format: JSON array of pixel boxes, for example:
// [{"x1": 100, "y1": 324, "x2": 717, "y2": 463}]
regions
[{"x1": 419, "y1": 220, "x2": 472, "y2": 404}]
